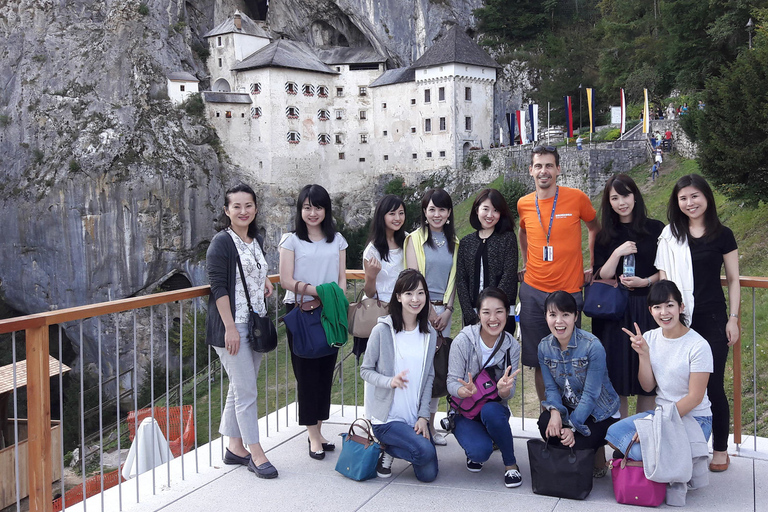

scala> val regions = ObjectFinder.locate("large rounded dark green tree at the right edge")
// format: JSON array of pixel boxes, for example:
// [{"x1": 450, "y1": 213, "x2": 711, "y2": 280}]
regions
[{"x1": 693, "y1": 10, "x2": 768, "y2": 199}]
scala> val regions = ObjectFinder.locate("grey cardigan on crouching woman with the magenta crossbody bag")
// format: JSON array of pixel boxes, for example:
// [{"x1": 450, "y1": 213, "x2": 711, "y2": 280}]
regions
[{"x1": 448, "y1": 324, "x2": 520, "y2": 404}]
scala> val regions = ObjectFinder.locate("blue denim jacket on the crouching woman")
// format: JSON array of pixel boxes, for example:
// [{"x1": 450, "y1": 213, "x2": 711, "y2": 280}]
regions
[{"x1": 539, "y1": 327, "x2": 619, "y2": 436}]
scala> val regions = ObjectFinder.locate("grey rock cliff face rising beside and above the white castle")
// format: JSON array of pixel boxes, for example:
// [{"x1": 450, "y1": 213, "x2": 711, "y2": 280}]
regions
[{"x1": 0, "y1": 0, "x2": 482, "y2": 388}]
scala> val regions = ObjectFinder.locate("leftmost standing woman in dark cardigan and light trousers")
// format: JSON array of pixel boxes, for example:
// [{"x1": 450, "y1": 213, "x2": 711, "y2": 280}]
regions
[{"x1": 205, "y1": 184, "x2": 277, "y2": 478}]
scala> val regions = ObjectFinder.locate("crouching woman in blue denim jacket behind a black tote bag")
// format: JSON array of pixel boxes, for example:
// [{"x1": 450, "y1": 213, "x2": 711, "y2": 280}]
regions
[{"x1": 539, "y1": 291, "x2": 620, "y2": 477}]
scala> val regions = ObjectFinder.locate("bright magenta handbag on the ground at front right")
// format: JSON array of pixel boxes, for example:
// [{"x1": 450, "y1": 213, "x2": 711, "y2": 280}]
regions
[{"x1": 608, "y1": 439, "x2": 667, "y2": 507}]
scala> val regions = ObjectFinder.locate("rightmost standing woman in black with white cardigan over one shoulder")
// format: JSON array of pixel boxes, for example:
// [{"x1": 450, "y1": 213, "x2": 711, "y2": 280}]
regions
[{"x1": 656, "y1": 174, "x2": 741, "y2": 472}]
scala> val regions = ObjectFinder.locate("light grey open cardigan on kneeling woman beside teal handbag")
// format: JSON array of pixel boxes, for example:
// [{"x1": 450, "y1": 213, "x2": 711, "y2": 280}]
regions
[{"x1": 360, "y1": 315, "x2": 437, "y2": 422}]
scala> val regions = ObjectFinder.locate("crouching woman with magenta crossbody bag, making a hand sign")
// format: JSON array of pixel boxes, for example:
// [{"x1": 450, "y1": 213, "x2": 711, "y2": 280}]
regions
[{"x1": 448, "y1": 286, "x2": 523, "y2": 487}]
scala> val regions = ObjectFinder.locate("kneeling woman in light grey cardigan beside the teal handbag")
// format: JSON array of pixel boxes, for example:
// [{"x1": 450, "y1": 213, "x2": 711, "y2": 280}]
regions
[{"x1": 360, "y1": 269, "x2": 437, "y2": 482}]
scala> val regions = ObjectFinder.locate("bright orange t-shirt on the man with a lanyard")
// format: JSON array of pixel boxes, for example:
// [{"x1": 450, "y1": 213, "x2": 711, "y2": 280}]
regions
[{"x1": 517, "y1": 187, "x2": 596, "y2": 293}]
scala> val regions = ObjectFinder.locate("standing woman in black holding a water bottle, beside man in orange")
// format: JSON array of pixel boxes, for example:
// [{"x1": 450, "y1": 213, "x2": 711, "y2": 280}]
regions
[{"x1": 592, "y1": 174, "x2": 664, "y2": 418}]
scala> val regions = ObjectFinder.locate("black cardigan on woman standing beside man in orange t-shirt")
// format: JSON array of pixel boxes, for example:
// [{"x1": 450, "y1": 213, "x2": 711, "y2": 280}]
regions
[{"x1": 456, "y1": 230, "x2": 517, "y2": 325}]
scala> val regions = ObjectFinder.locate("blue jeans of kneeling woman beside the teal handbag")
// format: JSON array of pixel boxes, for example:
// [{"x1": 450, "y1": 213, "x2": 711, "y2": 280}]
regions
[{"x1": 373, "y1": 421, "x2": 437, "y2": 482}]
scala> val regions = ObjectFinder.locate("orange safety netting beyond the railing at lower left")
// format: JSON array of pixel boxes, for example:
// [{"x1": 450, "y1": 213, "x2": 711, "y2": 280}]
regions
[{"x1": 53, "y1": 405, "x2": 195, "y2": 512}]
